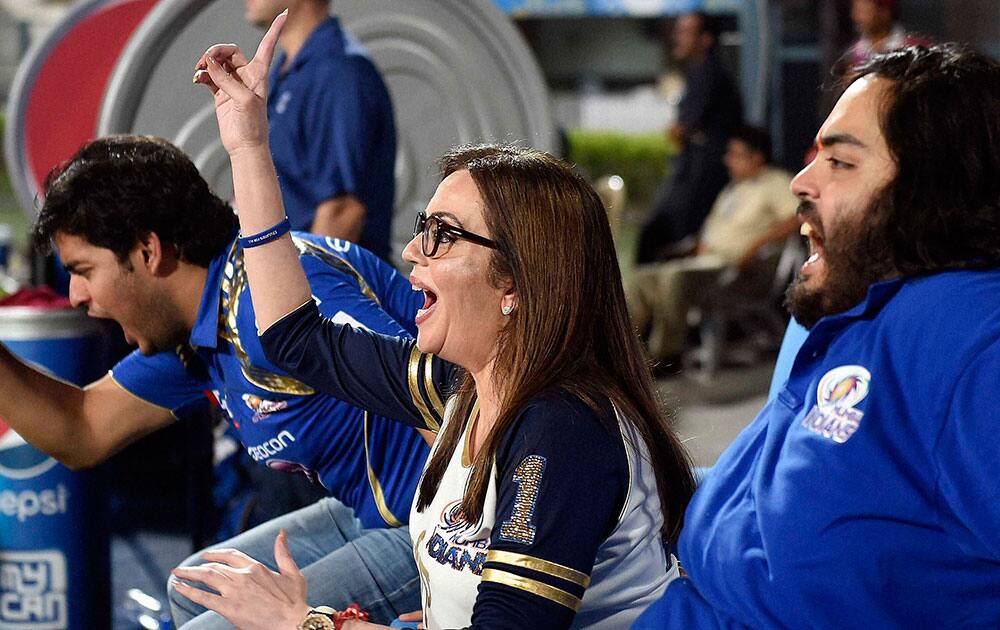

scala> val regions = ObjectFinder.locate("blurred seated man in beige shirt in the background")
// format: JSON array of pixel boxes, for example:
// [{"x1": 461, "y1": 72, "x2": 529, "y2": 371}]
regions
[{"x1": 627, "y1": 126, "x2": 798, "y2": 362}]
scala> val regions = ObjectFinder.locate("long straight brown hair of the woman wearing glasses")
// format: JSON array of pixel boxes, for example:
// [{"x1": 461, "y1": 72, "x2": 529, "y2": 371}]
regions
[{"x1": 417, "y1": 146, "x2": 694, "y2": 541}]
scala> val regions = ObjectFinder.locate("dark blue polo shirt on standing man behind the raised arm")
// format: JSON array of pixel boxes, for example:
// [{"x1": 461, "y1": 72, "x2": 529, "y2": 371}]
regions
[{"x1": 267, "y1": 17, "x2": 396, "y2": 260}]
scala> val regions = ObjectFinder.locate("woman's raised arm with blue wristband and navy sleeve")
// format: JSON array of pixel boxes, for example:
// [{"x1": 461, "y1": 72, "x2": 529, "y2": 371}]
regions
[{"x1": 194, "y1": 13, "x2": 454, "y2": 431}]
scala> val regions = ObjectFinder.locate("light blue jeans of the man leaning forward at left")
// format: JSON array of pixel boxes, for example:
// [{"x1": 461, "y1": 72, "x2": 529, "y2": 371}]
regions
[{"x1": 167, "y1": 498, "x2": 420, "y2": 630}]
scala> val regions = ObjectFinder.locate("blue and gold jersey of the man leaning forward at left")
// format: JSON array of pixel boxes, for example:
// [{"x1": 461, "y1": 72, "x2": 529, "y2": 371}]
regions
[{"x1": 112, "y1": 233, "x2": 428, "y2": 527}]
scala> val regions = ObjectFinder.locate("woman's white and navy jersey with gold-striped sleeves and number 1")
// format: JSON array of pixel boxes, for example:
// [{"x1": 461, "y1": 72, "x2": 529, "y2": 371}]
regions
[{"x1": 261, "y1": 303, "x2": 677, "y2": 629}]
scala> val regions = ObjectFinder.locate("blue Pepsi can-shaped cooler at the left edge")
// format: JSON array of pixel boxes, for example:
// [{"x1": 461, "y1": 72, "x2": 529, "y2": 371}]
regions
[{"x1": 0, "y1": 307, "x2": 111, "y2": 630}]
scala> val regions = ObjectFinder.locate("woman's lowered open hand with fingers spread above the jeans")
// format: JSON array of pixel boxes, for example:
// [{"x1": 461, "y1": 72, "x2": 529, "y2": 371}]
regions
[{"x1": 172, "y1": 530, "x2": 309, "y2": 630}]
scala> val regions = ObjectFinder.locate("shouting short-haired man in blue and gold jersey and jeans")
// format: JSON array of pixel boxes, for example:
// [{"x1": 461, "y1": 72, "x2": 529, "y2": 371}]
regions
[{"x1": 0, "y1": 136, "x2": 441, "y2": 627}]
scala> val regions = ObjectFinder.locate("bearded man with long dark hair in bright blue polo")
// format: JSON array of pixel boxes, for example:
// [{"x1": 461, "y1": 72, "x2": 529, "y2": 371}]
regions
[{"x1": 635, "y1": 46, "x2": 1000, "y2": 628}]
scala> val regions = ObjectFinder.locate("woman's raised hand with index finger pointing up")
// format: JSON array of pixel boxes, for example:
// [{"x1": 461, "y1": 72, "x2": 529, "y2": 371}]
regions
[{"x1": 192, "y1": 10, "x2": 288, "y2": 156}]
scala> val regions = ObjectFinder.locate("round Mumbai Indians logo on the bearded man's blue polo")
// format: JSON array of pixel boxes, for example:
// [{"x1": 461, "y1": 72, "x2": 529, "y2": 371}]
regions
[{"x1": 802, "y1": 365, "x2": 872, "y2": 444}]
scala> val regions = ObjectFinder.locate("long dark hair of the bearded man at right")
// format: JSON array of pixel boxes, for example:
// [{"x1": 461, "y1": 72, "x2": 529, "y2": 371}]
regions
[{"x1": 846, "y1": 44, "x2": 1000, "y2": 275}]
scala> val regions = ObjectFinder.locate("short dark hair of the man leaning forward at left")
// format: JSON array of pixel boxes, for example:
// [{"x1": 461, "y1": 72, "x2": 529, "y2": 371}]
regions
[{"x1": 33, "y1": 135, "x2": 238, "y2": 267}]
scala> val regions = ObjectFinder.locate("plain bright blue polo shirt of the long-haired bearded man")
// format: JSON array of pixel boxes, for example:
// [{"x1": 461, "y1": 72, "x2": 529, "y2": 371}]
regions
[{"x1": 635, "y1": 270, "x2": 1000, "y2": 630}]
